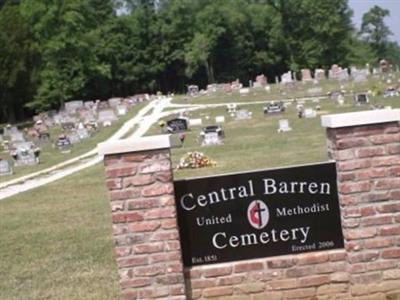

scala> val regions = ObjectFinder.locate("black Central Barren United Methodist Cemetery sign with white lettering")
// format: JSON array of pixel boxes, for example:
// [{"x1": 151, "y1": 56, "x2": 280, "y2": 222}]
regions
[{"x1": 174, "y1": 163, "x2": 344, "y2": 266}]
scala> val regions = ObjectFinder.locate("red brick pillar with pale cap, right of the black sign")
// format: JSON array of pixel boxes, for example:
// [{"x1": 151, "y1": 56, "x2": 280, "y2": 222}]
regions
[{"x1": 322, "y1": 110, "x2": 400, "y2": 297}]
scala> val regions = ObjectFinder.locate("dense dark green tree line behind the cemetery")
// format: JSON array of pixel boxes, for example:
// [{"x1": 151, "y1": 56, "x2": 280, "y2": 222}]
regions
[{"x1": 0, "y1": 0, "x2": 400, "y2": 123}]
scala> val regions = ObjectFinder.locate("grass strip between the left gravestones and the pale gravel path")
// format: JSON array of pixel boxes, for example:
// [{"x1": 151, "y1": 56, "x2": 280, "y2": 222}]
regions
[{"x1": 0, "y1": 103, "x2": 147, "y2": 181}]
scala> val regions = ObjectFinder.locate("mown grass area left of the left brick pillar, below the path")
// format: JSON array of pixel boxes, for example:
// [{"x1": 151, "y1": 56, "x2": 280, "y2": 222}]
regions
[{"x1": 0, "y1": 165, "x2": 119, "y2": 300}]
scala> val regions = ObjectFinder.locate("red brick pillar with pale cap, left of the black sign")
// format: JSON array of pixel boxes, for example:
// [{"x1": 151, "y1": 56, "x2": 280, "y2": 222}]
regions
[{"x1": 99, "y1": 136, "x2": 186, "y2": 299}]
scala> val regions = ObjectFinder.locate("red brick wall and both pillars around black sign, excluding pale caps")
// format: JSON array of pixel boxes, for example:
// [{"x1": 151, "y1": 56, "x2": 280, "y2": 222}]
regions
[{"x1": 101, "y1": 118, "x2": 400, "y2": 300}]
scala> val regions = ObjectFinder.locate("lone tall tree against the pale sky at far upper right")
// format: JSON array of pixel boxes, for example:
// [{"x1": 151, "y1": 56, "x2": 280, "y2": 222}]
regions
[{"x1": 360, "y1": 5, "x2": 392, "y2": 59}]
